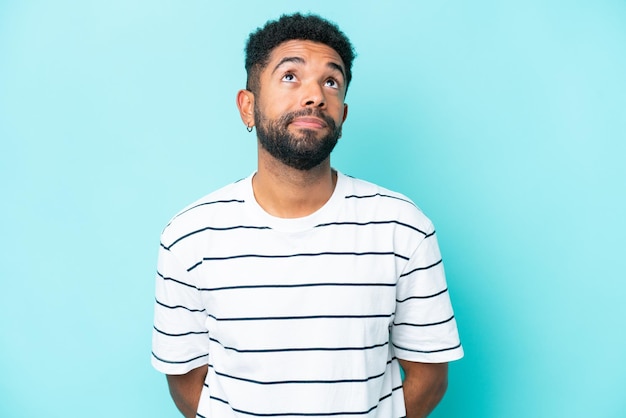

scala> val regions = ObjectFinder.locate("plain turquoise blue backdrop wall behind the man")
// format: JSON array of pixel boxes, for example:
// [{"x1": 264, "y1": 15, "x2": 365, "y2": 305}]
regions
[{"x1": 0, "y1": 0, "x2": 626, "y2": 418}]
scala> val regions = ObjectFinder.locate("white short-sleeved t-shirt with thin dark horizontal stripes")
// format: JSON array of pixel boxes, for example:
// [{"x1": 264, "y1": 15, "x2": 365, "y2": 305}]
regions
[{"x1": 152, "y1": 173, "x2": 463, "y2": 418}]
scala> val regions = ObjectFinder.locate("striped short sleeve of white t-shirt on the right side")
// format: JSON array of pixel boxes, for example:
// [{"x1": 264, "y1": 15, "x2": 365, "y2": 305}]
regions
[{"x1": 391, "y1": 229, "x2": 463, "y2": 363}]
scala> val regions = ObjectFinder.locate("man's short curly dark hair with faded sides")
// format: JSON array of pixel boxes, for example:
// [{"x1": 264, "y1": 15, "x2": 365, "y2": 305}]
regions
[{"x1": 245, "y1": 13, "x2": 356, "y2": 92}]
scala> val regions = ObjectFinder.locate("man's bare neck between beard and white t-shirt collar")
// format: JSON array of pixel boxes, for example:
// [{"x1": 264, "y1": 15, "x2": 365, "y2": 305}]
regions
[{"x1": 252, "y1": 150, "x2": 337, "y2": 218}]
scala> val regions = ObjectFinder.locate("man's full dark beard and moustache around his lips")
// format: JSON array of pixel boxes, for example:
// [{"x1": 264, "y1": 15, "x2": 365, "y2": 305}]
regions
[{"x1": 254, "y1": 103, "x2": 341, "y2": 171}]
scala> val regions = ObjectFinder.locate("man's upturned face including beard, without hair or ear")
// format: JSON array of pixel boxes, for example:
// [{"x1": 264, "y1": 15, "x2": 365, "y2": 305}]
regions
[{"x1": 254, "y1": 40, "x2": 347, "y2": 170}]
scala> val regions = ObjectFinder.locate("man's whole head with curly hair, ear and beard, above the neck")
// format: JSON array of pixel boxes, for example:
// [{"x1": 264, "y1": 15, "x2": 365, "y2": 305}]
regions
[{"x1": 237, "y1": 14, "x2": 354, "y2": 170}]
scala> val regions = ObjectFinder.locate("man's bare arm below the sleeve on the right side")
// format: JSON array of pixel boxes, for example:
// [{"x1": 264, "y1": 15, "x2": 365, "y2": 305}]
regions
[{"x1": 400, "y1": 360, "x2": 448, "y2": 418}]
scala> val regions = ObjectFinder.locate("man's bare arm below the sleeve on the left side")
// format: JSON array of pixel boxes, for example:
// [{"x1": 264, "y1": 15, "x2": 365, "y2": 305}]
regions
[{"x1": 167, "y1": 365, "x2": 209, "y2": 418}]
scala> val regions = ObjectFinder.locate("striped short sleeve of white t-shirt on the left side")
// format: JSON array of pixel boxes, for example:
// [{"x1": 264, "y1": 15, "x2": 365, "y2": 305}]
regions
[{"x1": 152, "y1": 246, "x2": 209, "y2": 374}]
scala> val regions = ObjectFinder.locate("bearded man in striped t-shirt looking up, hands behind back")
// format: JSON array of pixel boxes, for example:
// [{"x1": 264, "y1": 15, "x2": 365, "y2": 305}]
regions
[{"x1": 152, "y1": 14, "x2": 463, "y2": 418}]
